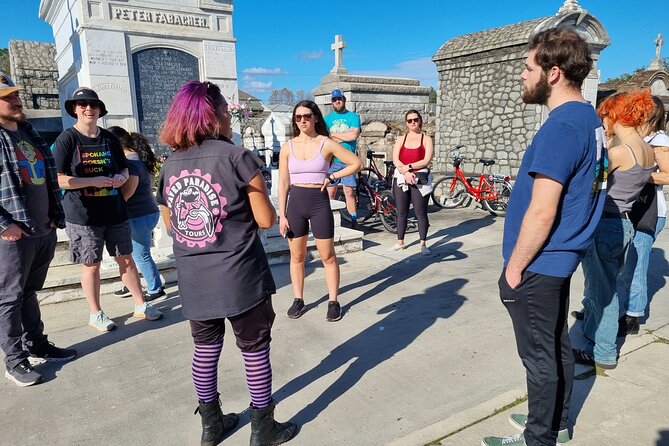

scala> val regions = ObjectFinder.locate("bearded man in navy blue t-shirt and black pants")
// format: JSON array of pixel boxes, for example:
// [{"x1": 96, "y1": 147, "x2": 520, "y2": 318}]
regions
[{"x1": 483, "y1": 28, "x2": 606, "y2": 446}]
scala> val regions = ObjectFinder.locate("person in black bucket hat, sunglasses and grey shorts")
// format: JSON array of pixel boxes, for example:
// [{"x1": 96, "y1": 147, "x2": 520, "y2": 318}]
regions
[{"x1": 53, "y1": 87, "x2": 162, "y2": 332}]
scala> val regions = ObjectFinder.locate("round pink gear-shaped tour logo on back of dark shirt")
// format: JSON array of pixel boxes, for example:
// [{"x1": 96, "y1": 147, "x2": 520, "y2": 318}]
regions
[{"x1": 165, "y1": 169, "x2": 228, "y2": 248}]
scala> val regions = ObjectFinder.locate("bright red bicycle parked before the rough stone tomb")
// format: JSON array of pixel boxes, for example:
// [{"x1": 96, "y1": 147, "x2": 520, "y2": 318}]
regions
[{"x1": 432, "y1": 146, "x2": 513, "y2": 217}]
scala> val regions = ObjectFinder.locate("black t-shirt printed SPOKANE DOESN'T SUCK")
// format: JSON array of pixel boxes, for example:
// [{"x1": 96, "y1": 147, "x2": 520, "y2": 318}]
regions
[{"x1": 53, "y1": 128, "x2": 128, "y2": 226}]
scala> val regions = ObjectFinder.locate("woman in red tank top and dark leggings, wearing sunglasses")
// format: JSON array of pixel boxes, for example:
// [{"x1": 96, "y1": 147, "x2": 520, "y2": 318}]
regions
[{"x1": 389, "y1": 110, "x2": 434, "y2": 255}]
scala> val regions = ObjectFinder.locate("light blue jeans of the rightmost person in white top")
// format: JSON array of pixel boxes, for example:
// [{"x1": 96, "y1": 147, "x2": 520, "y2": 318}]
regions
[{"x1": 618, "y1": 217, "x2": 666, "y2": 317}]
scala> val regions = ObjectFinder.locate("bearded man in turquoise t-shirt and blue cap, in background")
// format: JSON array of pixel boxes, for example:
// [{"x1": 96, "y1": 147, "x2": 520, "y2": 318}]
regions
[{"x1": 323, "y1": 89, "x2": 360, "y2": 229}]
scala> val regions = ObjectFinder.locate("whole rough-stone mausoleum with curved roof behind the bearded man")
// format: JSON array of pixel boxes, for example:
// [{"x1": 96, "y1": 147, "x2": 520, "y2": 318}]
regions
[{"x1": 432, "y1": 0, "x2": 610, "y2": 175}]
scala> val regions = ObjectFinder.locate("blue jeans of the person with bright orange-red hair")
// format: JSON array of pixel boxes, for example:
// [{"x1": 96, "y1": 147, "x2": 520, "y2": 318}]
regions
[{"x1": 583, "y1": 215, "x2": 634, "y2": 365}]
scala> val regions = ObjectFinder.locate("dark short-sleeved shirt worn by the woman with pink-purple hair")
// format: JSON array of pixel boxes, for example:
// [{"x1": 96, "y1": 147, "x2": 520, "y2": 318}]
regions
[{"x1": 156, "y1": 140, "x2": 276, "y2": 321}]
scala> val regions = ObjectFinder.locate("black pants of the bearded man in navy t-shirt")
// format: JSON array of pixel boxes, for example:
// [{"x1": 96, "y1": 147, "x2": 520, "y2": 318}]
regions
[{"x1": 499, "y1": 271, "x2": 574, "y2": 446}]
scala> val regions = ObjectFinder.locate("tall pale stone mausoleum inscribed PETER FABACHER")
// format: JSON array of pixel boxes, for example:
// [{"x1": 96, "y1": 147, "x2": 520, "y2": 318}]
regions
[{"x1": 39, "y1": 0, "x2": 239, "y2": 152}]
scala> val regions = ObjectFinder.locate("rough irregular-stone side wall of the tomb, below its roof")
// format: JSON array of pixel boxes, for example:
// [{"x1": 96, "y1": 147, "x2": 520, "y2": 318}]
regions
[{"x1": 433, "y1": 47, "x2": 545, "y2": 174}]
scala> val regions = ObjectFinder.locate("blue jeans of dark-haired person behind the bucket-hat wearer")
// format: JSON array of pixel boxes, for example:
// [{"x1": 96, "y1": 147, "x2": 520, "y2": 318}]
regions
[{"x1": 129, "y1": 212, "x2": 163, "y2": 293}]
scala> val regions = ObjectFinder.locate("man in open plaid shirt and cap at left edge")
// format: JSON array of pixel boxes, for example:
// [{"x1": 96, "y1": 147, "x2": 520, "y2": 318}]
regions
[{"x1": 0, "y1": 72, "x2": 77, "y2": 387}]
